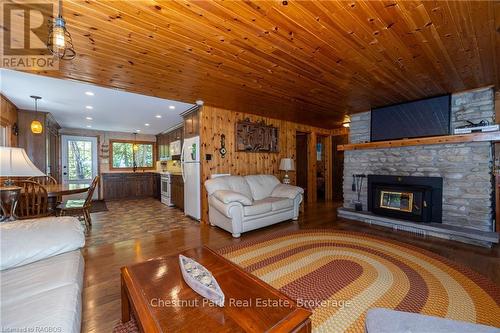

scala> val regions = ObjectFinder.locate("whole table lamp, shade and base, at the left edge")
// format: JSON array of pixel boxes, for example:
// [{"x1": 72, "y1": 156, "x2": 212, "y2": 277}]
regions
[{"x1": 0, "y1": 147, "x2": 45, "y2": 222}]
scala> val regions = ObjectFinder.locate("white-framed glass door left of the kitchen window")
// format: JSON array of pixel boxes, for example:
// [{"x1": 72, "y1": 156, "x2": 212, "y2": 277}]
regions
[{"x1": 61, "y1": 135, "x2": 99, "y2": 199}]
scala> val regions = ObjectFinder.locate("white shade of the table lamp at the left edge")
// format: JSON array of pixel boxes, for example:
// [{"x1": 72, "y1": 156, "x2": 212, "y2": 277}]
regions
[{"x1": 0, "y1": 147, "x2": 45, "y2": 177}]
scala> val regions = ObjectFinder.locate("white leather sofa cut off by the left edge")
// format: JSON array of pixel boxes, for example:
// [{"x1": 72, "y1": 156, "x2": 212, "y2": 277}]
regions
[{"x1": 0, "y1": 216, "x2": 85, "y2": 333}]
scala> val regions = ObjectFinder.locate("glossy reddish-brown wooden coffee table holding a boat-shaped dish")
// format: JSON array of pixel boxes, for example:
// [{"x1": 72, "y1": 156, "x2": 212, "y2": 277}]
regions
[{"x1": 121, "y1": 247, "x2": 311, "y2": 333}]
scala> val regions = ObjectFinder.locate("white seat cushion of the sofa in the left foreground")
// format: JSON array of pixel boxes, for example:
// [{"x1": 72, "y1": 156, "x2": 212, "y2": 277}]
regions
[{"x1": 0, "y1": 251, "x2": 84, "y2": 307}]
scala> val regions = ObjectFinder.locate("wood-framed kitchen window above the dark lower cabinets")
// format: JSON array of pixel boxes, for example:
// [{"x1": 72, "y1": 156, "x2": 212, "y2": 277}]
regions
[{"x1": 109, "y1": 140, "x2": 155, "y2": 169}]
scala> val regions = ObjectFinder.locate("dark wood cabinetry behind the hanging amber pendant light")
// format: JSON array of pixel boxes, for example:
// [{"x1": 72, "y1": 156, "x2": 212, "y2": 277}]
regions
[{"x1": 18, "y1": 110, "x2": 61, "y2": 181}]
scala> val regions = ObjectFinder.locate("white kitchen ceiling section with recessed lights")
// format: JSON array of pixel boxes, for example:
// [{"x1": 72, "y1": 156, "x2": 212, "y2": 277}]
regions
[{"x1": 0, "y1": 69, "x2": 194, "y2": 134}]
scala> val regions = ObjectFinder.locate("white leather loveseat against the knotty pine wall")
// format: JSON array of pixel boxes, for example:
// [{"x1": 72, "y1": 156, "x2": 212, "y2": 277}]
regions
[{"x1": 205, "y1": 175, "x2": 304, "y2": 237}]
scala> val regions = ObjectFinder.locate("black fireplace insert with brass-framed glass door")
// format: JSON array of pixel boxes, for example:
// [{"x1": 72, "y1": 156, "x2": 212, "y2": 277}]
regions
[{"x1": 368, "y1": 175, "x2": 443, "y2": 223}]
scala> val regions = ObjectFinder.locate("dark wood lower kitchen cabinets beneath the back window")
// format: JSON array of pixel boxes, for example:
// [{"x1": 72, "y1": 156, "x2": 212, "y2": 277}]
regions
[{"x1": 102, "y1": 172, "x2": 160, "y2": 200}]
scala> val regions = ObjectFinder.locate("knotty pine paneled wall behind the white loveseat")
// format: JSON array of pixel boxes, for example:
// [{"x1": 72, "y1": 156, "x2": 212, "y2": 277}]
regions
[{"x1": 200, "y1": 106, "x2": 346, "y2": 222}]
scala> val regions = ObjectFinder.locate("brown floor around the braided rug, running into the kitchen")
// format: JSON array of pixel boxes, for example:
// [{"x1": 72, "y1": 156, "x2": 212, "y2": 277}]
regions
[{"x1": 82, "y1": 199, "x2": 500, "y2": 332}]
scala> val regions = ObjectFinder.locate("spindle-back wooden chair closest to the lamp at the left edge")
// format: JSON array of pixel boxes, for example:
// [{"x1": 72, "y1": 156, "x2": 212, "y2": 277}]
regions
[{"x1": 15, "y1": 180, "x2": 50, "y2": 220}]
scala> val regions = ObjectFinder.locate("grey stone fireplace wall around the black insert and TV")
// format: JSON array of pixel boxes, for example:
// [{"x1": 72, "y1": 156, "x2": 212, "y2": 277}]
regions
[{"x1": 339, "y1": 88, "x2": 494, "y2": 244}]
